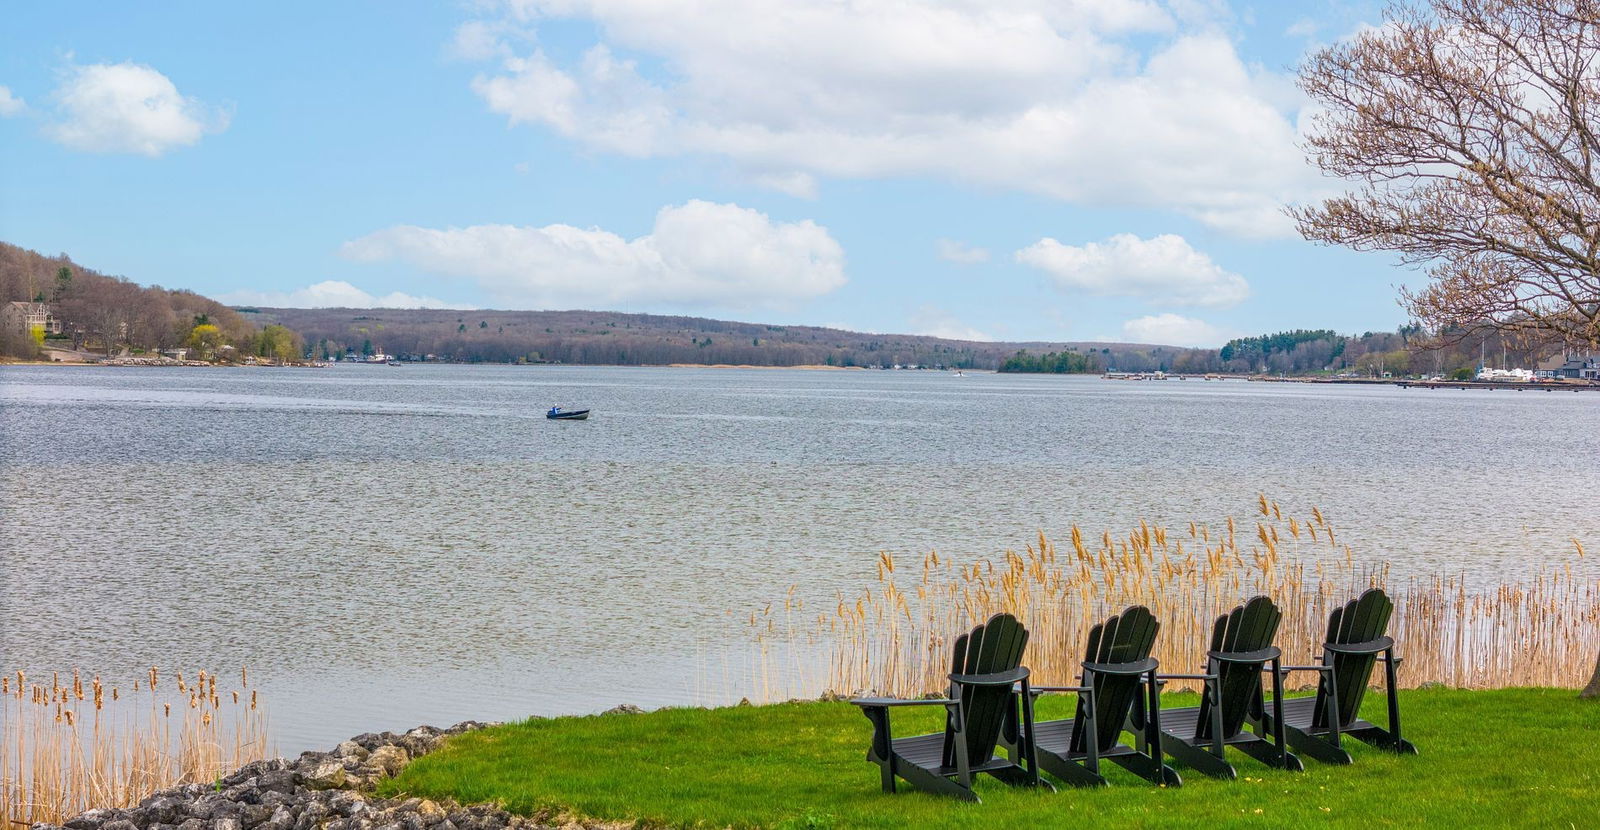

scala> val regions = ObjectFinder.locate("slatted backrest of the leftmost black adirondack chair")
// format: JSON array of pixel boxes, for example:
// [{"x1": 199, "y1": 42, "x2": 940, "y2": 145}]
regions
[{"x1": 944, "y1": 614, "x2": 1027, "y2": 766}]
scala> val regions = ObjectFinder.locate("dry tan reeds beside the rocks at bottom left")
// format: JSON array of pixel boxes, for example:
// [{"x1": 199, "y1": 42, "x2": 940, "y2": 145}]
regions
[{"x1": 0, "y1": 668, "x2": 267, "y2": 830}]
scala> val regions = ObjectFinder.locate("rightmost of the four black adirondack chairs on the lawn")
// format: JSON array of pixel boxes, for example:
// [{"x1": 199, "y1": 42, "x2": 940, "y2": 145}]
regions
[{"x1": 1259, "y1": 589, "x2": 1416, "y2": 764}]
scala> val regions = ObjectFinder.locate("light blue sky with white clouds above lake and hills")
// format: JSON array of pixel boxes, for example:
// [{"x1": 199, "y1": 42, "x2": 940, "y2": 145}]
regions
[{"x1": 0, "y1": 0, "x2": 1418, "y2": 345}]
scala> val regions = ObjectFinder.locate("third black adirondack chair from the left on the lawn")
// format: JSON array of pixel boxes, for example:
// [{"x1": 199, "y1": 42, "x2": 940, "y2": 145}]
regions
[{"x1": 1158, "y1": 597, "x2": 1304, "y2": 779}]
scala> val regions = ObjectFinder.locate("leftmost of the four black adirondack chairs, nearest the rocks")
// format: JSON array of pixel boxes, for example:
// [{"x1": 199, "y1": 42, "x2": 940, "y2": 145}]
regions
[{"x1": 851, "y1": 614, "x2": 1050, "y2": 801}]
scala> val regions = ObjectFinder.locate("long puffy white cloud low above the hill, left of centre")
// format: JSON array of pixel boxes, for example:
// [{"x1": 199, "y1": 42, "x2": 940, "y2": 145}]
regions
[{"x1": 341, "y1": 200, "x2": 845, "y2": 309}]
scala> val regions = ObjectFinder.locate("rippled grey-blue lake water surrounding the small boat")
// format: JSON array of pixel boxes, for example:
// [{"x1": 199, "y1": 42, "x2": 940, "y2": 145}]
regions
[{"x1": 0, "y1": 366, "x2": 1600, "y2": 752}]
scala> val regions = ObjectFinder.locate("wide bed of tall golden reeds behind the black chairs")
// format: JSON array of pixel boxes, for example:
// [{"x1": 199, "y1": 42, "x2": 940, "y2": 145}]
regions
[{"x1": 749, "y1": 496, "x2": 1600, "y2": 699}]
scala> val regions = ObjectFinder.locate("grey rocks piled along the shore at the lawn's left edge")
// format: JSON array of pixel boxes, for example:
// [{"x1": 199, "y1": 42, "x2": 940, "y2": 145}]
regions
[{"x1": 32, "y1": 707, "x2": 638, "y2": 830}]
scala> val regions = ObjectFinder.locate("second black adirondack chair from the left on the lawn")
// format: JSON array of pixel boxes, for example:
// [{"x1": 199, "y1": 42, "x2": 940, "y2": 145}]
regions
[{"x1": 1034, "y1": 605, "x2": 1182, "y2": 787}]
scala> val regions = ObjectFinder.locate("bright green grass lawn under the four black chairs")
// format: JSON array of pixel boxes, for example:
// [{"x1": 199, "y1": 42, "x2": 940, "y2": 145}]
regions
[{"x1": 384, "y1": 689, "x2": 1600, "y2": 830}]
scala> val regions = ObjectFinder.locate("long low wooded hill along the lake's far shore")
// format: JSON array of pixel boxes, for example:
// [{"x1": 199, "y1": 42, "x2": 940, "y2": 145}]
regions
[{"x1": 237, "y1": 307, "x2": 1196, "y2": 371}]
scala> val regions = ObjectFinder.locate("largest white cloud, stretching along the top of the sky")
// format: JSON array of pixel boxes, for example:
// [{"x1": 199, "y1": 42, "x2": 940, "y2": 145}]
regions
[{"x1": 460, "y1": 0, "x2": 1317, "y2": 235}]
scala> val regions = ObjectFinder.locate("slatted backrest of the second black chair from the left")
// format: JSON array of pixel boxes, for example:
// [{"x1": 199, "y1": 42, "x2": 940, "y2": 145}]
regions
[{"x1": 1070, "y1": 605, "x2": 1162, "y2": 752}]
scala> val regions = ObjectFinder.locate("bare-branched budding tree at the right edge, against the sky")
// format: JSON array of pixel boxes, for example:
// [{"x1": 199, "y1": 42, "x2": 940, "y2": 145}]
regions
[{"x1": 1290, "y1": 0, "x2": 1600, "y2": 697}]
